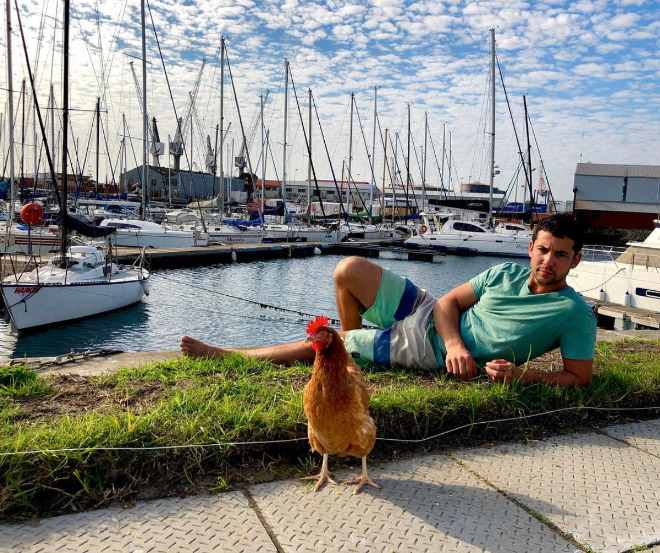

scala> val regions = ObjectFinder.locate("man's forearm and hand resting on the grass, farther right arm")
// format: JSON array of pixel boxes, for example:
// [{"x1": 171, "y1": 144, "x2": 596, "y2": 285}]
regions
[{"x1": 486, "y1": 357, "x2": 594, "y2": 387}]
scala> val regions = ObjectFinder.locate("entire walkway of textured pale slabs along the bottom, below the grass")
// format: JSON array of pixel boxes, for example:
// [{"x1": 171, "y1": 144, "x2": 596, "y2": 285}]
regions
[{"x1": 0, "y1": 420, "x2": 660, "y2": 553}]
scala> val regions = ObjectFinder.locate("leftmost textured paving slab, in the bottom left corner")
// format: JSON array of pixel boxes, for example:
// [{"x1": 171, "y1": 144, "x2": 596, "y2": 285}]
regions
[{"x1": 0, "y1": 492, "x2": 277, "y2": 553}]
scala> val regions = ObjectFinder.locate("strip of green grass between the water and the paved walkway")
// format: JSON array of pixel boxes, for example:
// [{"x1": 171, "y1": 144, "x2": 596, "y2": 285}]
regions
[{"x1": 0, "y1": 341, "x2": 660, "y2": 518}]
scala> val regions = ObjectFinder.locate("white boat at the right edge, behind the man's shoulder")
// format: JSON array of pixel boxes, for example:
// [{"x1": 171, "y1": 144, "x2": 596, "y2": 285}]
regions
[{"x1": 567, "y1": 219, "x2": 660, "y2": 312}]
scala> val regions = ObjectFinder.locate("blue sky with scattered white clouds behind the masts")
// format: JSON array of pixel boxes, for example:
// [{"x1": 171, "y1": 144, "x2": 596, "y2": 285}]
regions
[{"x1": 0, "y1": 0, "x2": 660, "y2": 200}]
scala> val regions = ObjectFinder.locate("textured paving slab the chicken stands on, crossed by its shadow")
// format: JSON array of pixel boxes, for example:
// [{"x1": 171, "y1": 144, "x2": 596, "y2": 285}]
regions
[{"x1": 250, "y1": 455, "x2": 576, "y2": 553}]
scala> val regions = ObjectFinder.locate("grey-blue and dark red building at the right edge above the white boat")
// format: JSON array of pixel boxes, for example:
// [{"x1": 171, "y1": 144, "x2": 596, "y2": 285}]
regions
[{"x1": 573, "y1": 163, "x2": 660, "y2": 229}]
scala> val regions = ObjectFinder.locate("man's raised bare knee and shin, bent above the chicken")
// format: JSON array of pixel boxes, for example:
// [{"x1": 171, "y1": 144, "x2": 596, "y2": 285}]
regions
[{"x1": 333, "y1": 257, "x2": 383, "y2": 330}]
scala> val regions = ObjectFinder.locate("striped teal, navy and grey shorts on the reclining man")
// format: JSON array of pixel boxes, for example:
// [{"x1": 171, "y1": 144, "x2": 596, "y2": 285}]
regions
[{"x1": 344, "y1": 268, "x2": 443, "y2": 369}]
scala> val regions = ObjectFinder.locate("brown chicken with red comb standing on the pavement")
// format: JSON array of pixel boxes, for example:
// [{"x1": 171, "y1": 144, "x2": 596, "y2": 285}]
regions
[{"x1": 303, "y1": 317, "x2": 380, "y2": 493}]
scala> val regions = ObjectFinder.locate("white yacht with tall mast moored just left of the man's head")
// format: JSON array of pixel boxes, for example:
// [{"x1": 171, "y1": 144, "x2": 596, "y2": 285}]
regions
[{"x1": 405, "y1": 29, "x2": 531, "y2": 257}]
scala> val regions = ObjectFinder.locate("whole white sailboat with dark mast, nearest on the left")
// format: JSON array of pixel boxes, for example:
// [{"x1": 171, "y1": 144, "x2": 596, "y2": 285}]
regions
[{"x1": 0, "y1": 0, "x2": 150, "y2": 330}]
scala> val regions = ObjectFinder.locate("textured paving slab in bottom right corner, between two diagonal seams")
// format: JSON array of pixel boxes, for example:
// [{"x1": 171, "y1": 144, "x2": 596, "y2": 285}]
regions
[{"x1": 454, "y1": 434, "x2": 660, "y2": 552}]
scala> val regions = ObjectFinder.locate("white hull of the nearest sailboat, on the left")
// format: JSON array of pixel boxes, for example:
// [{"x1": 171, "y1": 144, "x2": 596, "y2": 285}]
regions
[{"x1": 0, "y1": 270, "x2": 149, "y2": 330}]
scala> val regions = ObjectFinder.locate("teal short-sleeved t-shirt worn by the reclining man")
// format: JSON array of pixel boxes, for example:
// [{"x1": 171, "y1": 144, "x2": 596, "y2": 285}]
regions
[{"x1": 432, "y1": 263, "x2": 596, "y2": 367}]
